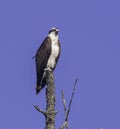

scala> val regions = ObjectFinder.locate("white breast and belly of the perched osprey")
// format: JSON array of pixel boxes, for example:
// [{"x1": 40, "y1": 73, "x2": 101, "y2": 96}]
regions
[{"x1": 47, "y1": 34, "x2": 59, "y2": 68}]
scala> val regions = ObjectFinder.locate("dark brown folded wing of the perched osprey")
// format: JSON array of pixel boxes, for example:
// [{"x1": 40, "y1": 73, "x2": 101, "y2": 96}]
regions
[{"x1": 35, "y1": 37, "x2": 51, "y2": 92}]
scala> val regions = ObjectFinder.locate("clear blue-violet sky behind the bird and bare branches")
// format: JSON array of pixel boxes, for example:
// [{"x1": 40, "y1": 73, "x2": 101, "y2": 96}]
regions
[{"x1": 0, "y1": 0, "x2": 120, "y2": 129}]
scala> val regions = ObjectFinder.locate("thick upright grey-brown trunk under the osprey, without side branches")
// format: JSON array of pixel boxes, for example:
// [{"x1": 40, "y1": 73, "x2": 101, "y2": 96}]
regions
[{"x1": 45, "y1": 70, "x2": 56, "y2": 129}]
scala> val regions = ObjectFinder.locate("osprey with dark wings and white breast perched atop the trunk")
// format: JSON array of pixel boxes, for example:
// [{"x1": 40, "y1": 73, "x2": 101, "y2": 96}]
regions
[{"x1": 35, "y1": 28, "x2": 61, "y2": 94}]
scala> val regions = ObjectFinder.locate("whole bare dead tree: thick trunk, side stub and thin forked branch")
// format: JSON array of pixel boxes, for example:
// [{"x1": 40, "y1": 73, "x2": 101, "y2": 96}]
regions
[{"x1": 34, "y1": 69, "x2": 77, "y2": 129}]
